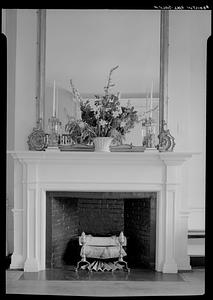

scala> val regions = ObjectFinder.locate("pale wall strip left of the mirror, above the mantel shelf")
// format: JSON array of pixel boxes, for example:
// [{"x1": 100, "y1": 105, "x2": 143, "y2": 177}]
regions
[{"x1": 15, "y1": 9, "x2": 37, "y2": 150}]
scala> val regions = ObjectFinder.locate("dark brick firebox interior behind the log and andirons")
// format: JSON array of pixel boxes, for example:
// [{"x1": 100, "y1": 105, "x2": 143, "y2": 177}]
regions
[{"x1": 46, "y1": 191, "x2": 157, "y2": 269}]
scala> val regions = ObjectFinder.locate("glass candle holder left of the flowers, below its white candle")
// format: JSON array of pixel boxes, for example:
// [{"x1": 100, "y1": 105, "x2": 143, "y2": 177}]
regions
[{"x1": 46, "y1": 116, "x2": 61, "y2": 151}]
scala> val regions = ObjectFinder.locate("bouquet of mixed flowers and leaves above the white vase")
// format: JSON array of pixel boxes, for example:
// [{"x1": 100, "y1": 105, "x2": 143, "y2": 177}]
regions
[{"x1": 65, "y1": 66, "x2": 138, "y2": 144}]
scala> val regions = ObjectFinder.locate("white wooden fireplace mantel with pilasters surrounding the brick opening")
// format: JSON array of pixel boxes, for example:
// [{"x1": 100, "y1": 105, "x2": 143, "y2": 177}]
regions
[{"x1": 8, "y1": 151, "x2": 193, "y2": 273}]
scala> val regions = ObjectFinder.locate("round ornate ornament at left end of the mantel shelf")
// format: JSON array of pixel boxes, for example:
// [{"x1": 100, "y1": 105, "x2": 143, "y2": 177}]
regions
[{"x1": 27, "y1": 119, "x2": 46, "y2": 151}]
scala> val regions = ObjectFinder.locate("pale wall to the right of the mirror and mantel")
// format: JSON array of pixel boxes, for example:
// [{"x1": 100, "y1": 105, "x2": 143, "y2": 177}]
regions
[{"x1": 168, "y1": 10, "x2": 211, "y2": 230}]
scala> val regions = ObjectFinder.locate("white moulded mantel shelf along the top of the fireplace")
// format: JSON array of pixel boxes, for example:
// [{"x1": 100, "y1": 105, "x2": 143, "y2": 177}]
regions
[{"x1": 7, "y1": 151, "x2": 199, "y2": 165}]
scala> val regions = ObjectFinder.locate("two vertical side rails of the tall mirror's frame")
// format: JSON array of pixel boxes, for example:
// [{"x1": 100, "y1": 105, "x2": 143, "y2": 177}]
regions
[{"x1": 36, "y1": 9, "x2": 171, "y2": 151}]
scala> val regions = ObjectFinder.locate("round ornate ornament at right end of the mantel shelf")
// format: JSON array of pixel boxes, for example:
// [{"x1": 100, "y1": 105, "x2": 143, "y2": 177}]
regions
[{"x1": 158, "y1": 121, "x2": 175, "y2": 152}]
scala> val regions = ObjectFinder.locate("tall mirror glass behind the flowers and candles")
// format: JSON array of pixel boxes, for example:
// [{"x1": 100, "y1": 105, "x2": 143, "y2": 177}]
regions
[{"x1": 35, "y1": 9, "x2": 168, "y2": 149}]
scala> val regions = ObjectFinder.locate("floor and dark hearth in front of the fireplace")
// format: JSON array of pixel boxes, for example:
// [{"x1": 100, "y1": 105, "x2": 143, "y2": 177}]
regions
[{"x1": 6, "y1": 269, "x2": 205, "y2": 297}]
